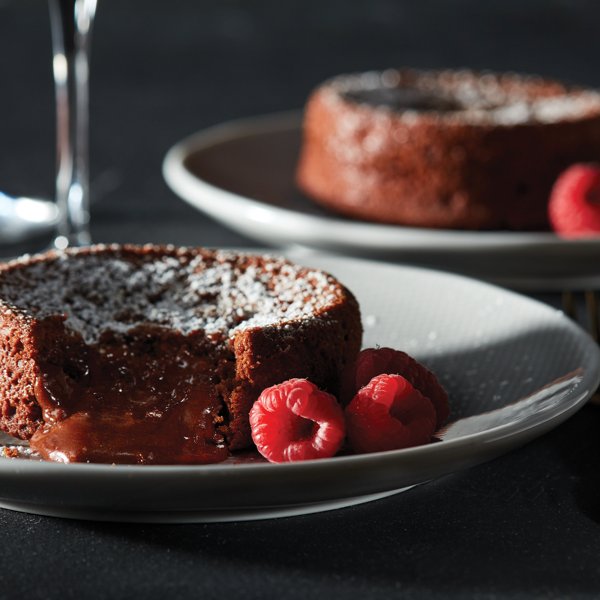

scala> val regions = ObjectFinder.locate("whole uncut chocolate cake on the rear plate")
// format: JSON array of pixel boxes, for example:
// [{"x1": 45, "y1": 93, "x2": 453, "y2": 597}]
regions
[{"x1": 297, "y1": 69, "x2": 600, "y2": 230}]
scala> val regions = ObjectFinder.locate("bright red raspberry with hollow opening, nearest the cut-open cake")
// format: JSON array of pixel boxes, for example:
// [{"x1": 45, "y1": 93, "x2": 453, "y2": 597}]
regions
[{"x1": 250, "y1": 379, "x2": 346, "y2": 462}]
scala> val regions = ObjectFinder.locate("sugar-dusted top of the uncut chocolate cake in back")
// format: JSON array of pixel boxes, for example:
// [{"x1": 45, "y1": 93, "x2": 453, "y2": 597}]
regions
[{"x1": 320, "y1": 69, "x2": 600, "y2": 125}]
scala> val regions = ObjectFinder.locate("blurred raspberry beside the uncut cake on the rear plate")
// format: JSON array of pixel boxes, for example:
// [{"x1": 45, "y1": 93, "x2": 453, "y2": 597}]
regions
[{"x1": 548, "y1": 164, "x2": 600, "y2": 238}]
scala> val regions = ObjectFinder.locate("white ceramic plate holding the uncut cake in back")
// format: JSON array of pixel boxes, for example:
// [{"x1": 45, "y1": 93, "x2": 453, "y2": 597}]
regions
[{"x1": 163, "y1": 113, "x2": 600, "y2": 288}]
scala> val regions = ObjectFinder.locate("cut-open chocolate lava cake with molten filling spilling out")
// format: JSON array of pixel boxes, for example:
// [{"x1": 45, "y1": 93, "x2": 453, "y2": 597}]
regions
[{"x1": 0, "y1": 245, "x2": 362, "y2": 464}]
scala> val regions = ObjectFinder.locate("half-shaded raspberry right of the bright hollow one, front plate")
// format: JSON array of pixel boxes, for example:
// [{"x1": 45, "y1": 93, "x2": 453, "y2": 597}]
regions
[{"x1": 346, "y1": 375, "x2": 436, "y2": 452}]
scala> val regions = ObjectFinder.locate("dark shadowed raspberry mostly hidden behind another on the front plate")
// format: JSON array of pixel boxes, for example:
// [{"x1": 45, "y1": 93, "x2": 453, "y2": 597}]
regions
[{"x1": 353, "y1": 348, "x2": 450, "y2": 429}]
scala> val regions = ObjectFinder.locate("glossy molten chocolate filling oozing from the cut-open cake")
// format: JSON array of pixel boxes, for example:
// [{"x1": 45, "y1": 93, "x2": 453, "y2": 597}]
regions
[{"x1": 30, "y1": 333, "x2": 228, "y2": 464}]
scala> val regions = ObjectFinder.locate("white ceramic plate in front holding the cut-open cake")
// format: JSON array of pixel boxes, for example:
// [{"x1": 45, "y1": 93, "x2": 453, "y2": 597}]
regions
[{"x1": 0, "y1": 256, "x2": 600, "y2": 522}]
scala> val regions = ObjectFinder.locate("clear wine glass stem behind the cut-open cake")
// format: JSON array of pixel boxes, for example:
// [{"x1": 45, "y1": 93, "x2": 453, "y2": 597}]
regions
[{"x1": 49, "y1": 0, "x2": 96, "y2": 248}]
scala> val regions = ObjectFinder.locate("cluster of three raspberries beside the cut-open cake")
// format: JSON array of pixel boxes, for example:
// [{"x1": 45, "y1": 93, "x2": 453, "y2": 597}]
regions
[{"x1": 250, "y1": 348, "x2": 450, "y2": 462}]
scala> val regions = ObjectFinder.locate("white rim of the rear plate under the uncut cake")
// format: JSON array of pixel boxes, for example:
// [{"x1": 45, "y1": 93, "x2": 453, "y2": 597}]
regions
[{"x1": 162, "y1": 110, "x2": 600, "y2": 253}]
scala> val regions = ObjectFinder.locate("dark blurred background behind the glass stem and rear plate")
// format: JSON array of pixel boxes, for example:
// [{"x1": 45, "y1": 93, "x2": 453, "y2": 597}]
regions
[{"x1": 0, "y1": 0, "x2": 600, "y2": 245}]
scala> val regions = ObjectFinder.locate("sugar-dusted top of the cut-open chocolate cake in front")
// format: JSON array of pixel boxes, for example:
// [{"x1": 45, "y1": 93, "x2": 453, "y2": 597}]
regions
[{"x1": 0, "y1": 245, "x2": 344, "y2": 344}]
